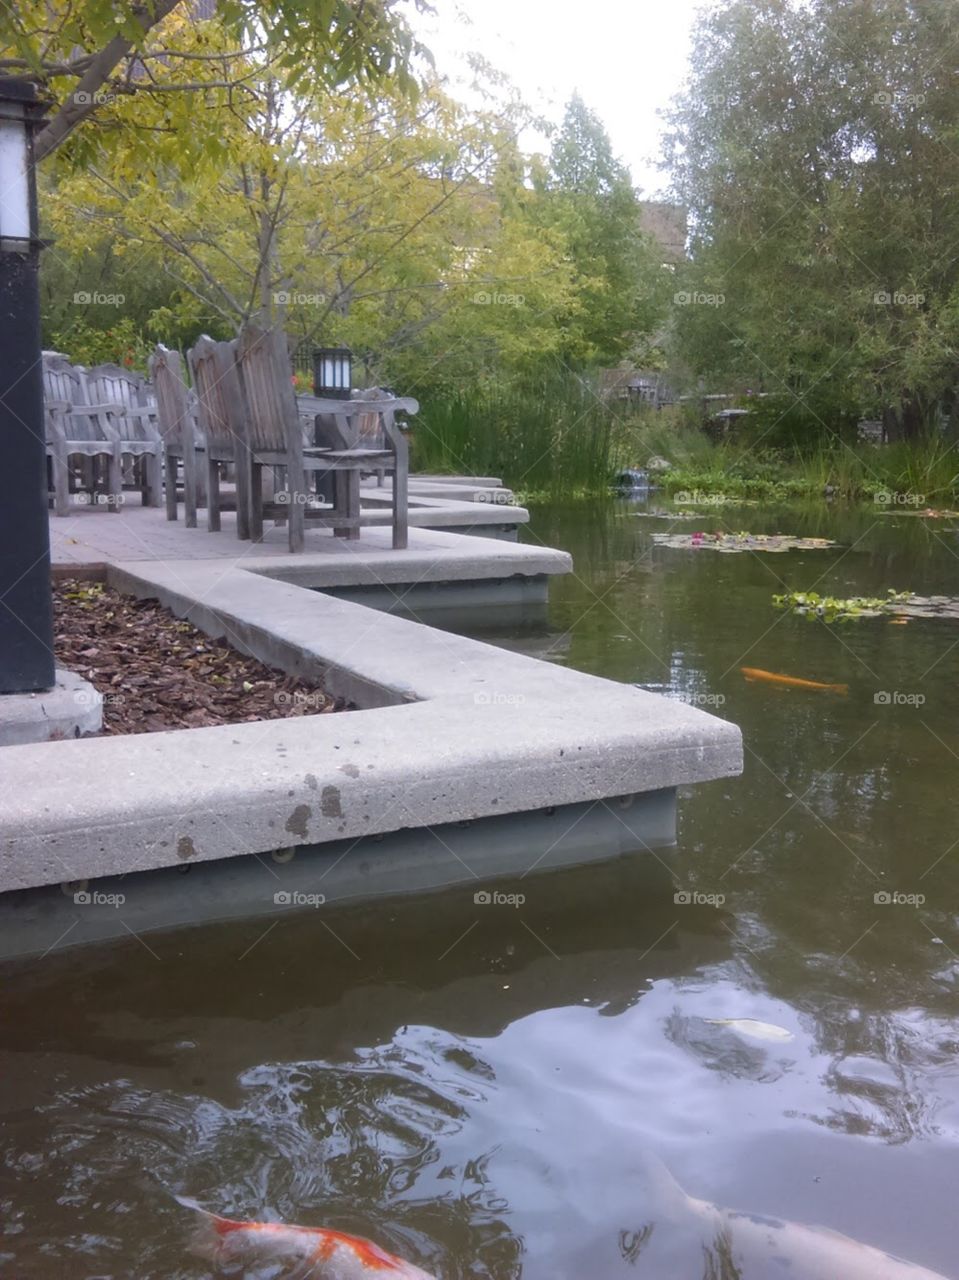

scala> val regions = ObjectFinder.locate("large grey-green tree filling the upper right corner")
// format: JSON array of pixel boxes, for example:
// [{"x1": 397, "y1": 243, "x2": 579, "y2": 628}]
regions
[{"x1": 670, "y1": 0, "x2": 959, "y2": 444}]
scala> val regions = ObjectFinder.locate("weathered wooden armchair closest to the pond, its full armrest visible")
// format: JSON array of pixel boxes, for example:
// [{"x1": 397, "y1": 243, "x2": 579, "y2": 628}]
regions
[{"x1": 237, "y1": 325, "x2": 419, "y2": 552}]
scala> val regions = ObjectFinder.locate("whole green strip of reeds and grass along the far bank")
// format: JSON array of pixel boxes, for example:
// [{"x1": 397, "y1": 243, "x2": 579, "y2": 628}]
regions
[{"x1": 412, "y1": 372, "x2": 959, "y2": 504}]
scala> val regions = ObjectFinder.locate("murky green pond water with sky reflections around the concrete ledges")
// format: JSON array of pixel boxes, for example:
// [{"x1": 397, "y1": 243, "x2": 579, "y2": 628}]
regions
[{"x1": 0, "y1": 498, "x2": 959, "y2": 1280}]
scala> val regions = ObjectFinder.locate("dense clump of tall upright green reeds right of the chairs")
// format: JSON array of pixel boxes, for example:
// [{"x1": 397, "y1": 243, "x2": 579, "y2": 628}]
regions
[{"x1": 411, "y1": 374, "x2": 627, "y2": 497}]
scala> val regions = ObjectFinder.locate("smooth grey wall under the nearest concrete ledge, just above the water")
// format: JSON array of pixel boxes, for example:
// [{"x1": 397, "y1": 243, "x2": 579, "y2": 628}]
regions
[{"x1": 0, "y1": 790, "x2": 676, "y2": 960}]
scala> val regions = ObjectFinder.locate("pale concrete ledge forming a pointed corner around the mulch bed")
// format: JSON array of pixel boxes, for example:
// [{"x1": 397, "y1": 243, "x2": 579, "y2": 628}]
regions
[{"x1": 0, "y1": 544, "x2": 741, "y2": 890}]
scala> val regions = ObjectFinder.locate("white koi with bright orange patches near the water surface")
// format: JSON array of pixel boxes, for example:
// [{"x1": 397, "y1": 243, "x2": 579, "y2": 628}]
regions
[{"x1": 174, "y1": 1196, "x2": 435, "y2": 1280}]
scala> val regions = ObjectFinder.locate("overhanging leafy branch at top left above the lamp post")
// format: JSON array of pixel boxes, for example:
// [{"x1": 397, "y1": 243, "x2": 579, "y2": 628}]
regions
[{"x1": 0, "y1": 0, "x2": 429, "y2": 163}]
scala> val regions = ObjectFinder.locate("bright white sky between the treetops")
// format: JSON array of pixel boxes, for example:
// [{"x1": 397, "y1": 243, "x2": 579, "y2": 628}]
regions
[{"x1": 412, "y1": 0, "x2": 703, "y2": 197}]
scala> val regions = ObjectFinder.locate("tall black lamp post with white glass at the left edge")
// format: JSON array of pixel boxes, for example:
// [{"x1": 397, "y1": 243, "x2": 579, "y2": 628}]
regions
[{"x1": 0, "y1": 78, "x2": 54, "y2": 694}]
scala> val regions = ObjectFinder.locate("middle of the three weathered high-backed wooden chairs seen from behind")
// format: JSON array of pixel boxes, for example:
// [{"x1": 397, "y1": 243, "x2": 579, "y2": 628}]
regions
[{"x1": 187, "y1": 334, "x2": 243, "y2": 538}]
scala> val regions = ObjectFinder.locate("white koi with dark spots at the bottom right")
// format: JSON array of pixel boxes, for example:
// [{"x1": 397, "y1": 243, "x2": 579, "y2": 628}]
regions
[{"x1": 627, "y1": 1153, "x2": 946, "y2": 1280}]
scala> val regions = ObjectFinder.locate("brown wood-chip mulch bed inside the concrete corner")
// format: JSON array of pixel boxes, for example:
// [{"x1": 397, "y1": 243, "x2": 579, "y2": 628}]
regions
[{"x1": 54, "y1": 579, "x2": 346, "y2": 733}]
